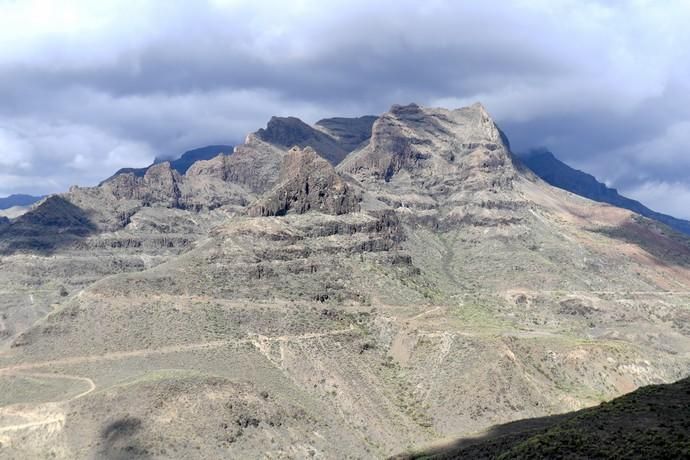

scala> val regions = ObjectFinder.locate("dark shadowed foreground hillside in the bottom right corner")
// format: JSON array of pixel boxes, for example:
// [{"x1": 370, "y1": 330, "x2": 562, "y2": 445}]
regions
[{"x1": 395, "y1": 379, "x2": 690, "y2": 460}]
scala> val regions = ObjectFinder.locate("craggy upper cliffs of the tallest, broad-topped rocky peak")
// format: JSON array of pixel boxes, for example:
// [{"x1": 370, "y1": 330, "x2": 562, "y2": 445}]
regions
[{"x1": 340, "y1": 104, "x2": 514, "y2": 185}]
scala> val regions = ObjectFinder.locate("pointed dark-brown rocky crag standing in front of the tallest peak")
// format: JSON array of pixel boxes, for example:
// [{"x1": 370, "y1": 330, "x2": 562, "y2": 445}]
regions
[{"x1": 249, "y1": 147, "x2": 361, "y2": 216}]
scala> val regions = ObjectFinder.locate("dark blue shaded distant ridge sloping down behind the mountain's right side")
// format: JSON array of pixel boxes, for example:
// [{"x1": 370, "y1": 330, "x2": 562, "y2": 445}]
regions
[{"x1": 521, "y1": 150, "x2": 690, "y2": 235}]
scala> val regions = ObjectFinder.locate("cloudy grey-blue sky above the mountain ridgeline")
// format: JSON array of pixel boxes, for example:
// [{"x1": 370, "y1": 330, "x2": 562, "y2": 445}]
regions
[{"x1": 0, "y1": 0, "x2": 690, "y2": 218}]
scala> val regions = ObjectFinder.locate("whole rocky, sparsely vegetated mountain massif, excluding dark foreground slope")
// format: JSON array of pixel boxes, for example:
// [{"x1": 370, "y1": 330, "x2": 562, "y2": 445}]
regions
[{"x1": 0, "y1": 104, "x2": 690, "y2": 458}]
